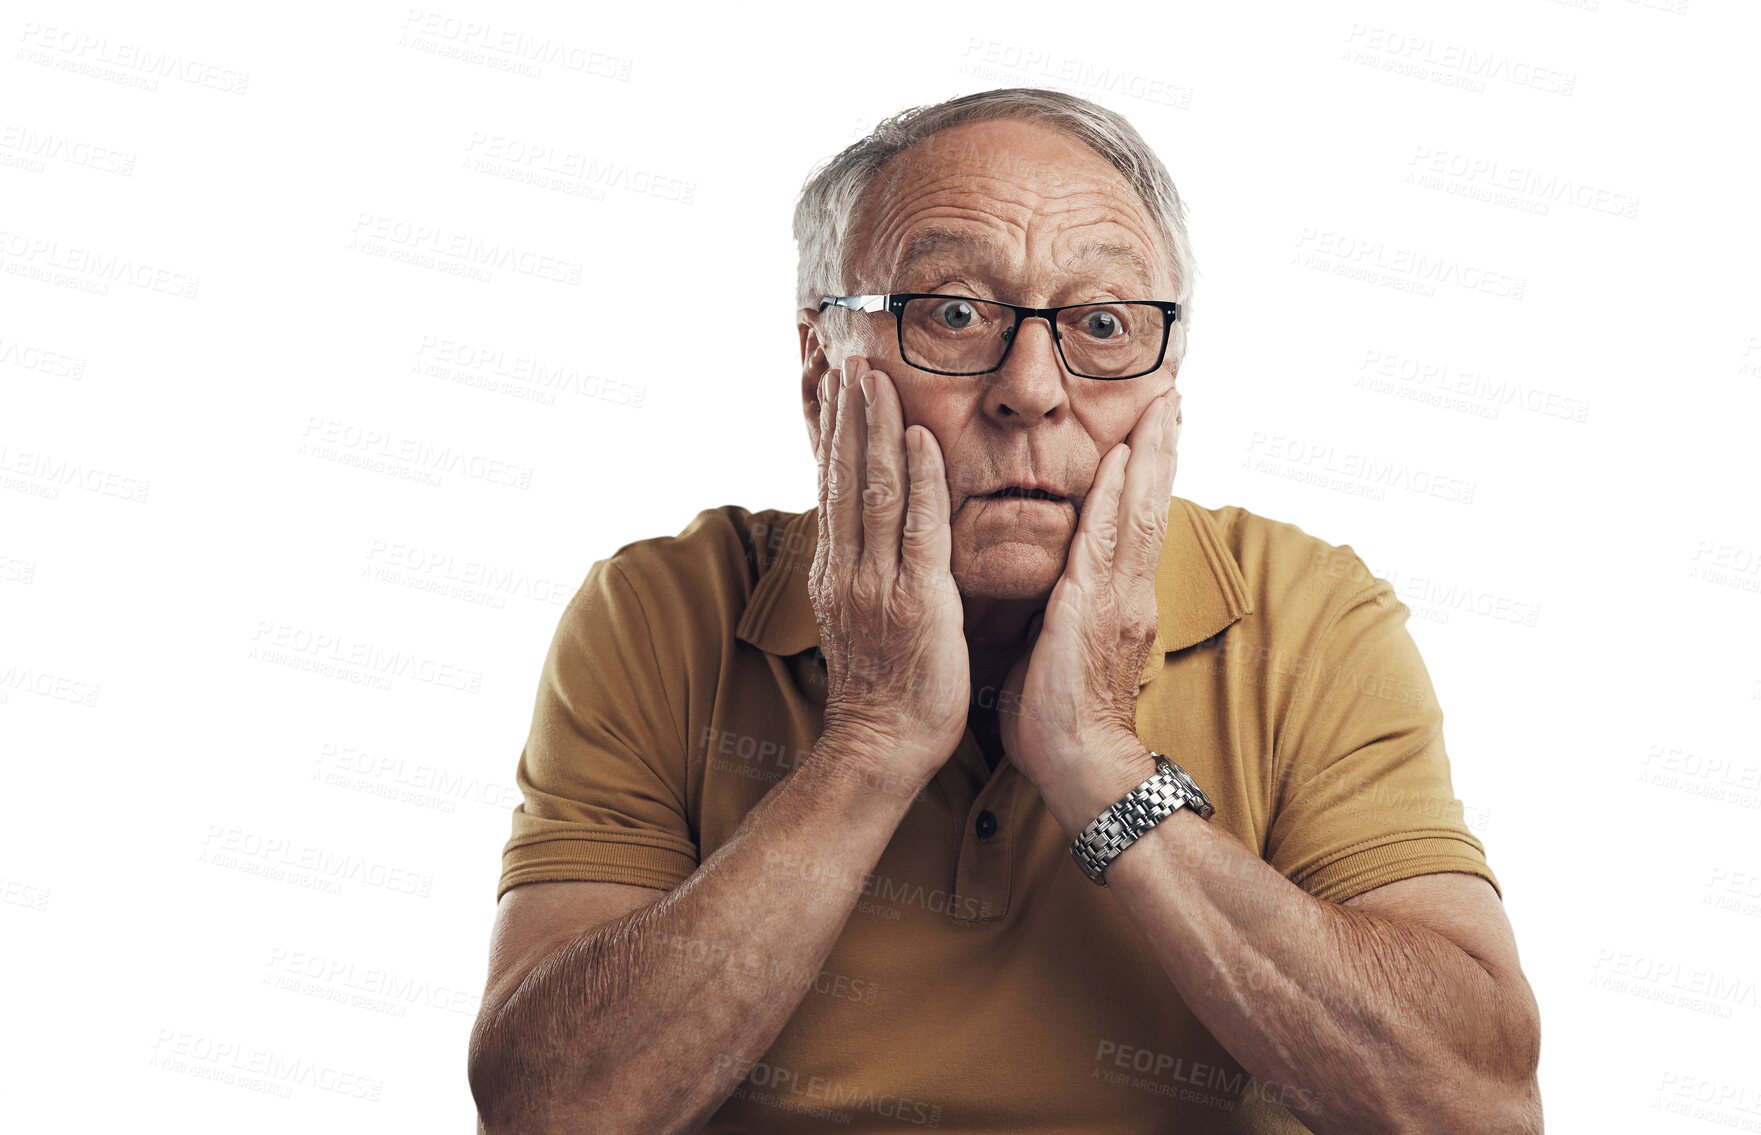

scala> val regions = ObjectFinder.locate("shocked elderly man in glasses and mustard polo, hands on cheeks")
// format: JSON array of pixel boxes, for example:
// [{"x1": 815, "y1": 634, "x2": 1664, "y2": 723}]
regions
[{"x1": 470, "y1": 90, "x2": 1541, "y2": 1135}]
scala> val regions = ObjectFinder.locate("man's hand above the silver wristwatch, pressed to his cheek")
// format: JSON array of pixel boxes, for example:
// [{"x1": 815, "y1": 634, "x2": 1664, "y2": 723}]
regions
[{"x1": 998, "y1": 391, "x2": 1180, "y2": 836}]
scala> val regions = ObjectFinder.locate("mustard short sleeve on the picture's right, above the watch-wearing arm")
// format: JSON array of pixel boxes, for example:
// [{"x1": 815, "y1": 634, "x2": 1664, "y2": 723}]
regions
[{"x1": 1266, "y1": 561, "x2": 1504, "y2": 903}]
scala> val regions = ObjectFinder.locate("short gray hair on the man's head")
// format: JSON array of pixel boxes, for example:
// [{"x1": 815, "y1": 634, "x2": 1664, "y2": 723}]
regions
[{"x1": 794, "y1": 86, "x2": 1196, "y2": 366}]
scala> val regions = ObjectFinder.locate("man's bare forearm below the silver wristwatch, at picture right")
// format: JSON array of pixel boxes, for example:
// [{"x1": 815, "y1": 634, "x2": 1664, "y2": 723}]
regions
[{"x1": 1108, "y1": 809, "x2": 1537, "y2": 1133}]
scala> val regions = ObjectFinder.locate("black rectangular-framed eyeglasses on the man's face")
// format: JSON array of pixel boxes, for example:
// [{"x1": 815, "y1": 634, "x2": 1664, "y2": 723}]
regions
[{"x1": 819, "y1": 292, "x2": 1180, "y2": 380}]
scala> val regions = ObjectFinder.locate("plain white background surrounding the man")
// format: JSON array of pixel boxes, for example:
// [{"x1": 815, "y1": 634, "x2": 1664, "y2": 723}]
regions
[{"x1": 0, "y1": 0, "x2": 1761, "y2": 1131}]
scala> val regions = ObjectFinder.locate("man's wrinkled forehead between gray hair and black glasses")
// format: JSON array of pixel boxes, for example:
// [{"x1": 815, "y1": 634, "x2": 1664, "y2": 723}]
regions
[{"x1": 845, "y1": 121, "x2": 1171, "y2": 296}]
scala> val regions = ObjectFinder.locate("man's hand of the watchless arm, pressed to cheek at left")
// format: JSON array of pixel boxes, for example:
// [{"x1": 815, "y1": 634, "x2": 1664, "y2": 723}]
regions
[{"x1": 808, "y1": 355, "x2": 972, "y2": 788}]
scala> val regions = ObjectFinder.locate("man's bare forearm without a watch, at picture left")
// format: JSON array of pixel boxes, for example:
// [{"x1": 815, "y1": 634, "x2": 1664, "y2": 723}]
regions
[{"x1": 472, "y1": 737, "x2": 910, "y2": 1131}]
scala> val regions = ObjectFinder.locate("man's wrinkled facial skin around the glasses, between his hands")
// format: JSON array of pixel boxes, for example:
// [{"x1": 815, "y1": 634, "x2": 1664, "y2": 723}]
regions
[{"x1": 801, "y1": 121, "x2": 1175, "y2": 598}]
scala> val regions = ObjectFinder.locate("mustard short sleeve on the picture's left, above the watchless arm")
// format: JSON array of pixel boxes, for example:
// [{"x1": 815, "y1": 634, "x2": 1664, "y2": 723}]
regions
[{"x1": 495, "y1": 560, "x2": 697, "y2": 901}]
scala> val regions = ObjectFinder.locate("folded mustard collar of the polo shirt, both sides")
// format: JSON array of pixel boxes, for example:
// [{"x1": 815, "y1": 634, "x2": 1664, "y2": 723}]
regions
[{"x1": 734, "y1": 496, "x2": 1254, "y2": 686}]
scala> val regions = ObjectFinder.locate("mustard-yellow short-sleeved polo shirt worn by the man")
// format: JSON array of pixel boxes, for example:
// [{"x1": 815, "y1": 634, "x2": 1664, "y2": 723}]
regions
[{"x1": 497, "y1": 496, "x2": 1502, "y2": 1135}]
